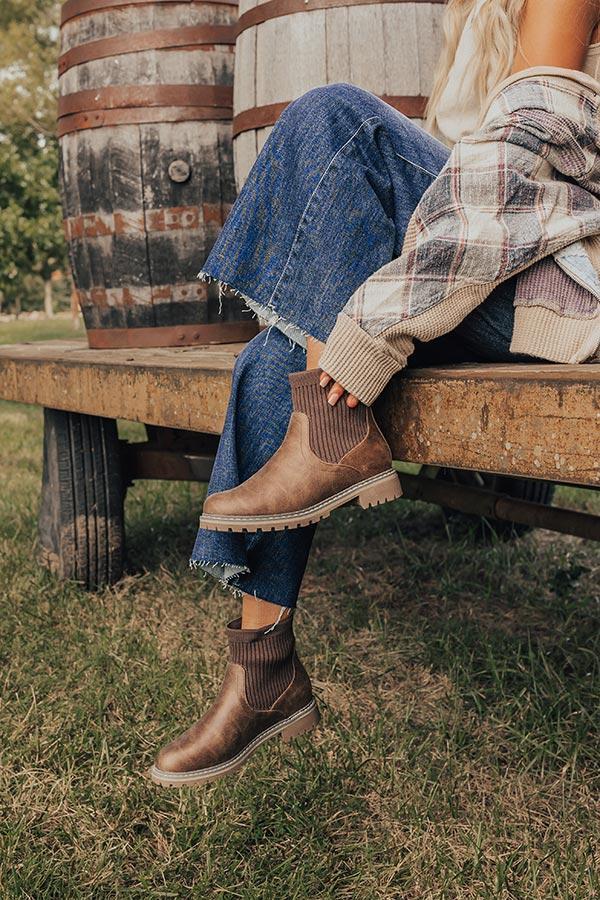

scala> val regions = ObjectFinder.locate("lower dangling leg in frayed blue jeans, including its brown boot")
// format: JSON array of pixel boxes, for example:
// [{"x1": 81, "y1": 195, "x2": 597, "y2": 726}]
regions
[{"x1": 150, "y1": 329, "x2": 318, "y2": 786}]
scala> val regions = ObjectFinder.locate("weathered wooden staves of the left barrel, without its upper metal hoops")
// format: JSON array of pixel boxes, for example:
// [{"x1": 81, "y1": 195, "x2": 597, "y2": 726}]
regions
[{"x1": 59, "y1": 2, "x2": 248, "y2": 344}]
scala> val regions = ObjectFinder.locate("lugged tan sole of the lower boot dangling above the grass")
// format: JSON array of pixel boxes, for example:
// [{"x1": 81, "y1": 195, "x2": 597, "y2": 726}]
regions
[{"x1": 148, "y1": 700, "x2": 321, "y2": 787}]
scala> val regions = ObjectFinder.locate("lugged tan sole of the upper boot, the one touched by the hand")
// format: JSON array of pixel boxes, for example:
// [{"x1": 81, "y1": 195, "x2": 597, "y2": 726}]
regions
[{"x1": 200, "y1": 469, "x2": 402, "y2": 533}]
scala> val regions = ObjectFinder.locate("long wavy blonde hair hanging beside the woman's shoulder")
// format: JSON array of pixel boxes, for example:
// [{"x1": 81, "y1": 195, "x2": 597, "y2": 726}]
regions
[{"x1": 425, "y1": 0, "x2": 527, "y2": 131}]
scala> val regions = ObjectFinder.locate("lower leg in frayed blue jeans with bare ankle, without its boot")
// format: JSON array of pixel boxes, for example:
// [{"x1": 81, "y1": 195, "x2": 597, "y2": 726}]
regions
[{"x1": 190, "y1": 328, "x2": 314, "y2": 608}]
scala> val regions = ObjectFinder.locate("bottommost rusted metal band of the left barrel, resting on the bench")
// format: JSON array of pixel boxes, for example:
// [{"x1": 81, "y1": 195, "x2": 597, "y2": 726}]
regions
[{"x1": 87, "y1": 320, "x2": 258, "y2": 350}]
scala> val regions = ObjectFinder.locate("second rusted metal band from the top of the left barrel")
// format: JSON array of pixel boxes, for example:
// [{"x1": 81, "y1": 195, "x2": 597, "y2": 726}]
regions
[{"x1": 58, "y1": 25, "x2": 235, "y2": 75}]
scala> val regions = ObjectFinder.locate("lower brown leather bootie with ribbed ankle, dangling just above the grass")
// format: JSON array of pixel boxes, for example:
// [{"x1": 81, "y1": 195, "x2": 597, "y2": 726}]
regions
[{"x1": 150, "y1": 615, "x2": 319, "y2": 787}]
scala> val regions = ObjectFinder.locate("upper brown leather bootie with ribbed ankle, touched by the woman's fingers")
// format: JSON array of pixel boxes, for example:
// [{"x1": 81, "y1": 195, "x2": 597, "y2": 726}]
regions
[{"x1": 200, "y1": 369, "x2": 402, "y2": 532}]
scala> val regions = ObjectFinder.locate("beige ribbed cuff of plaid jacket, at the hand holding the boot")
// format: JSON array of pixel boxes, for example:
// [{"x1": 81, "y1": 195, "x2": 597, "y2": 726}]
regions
[{"x1": 319, "y1": 313, "x2": 402, "y2": 406}]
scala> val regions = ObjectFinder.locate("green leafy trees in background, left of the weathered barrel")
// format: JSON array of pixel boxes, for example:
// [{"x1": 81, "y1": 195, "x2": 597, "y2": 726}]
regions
[{"x1": 0, "y1": 0, "x2": 68, "y2": 313}]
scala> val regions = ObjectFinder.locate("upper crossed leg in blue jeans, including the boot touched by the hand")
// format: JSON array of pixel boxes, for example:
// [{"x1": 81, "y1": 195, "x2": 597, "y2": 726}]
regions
[{"x1": 195, "y1": 84, "x2": 449, "y2": 532}]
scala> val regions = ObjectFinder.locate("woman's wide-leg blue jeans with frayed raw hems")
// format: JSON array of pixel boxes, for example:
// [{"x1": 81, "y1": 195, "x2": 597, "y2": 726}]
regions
[{"x1": 190, "y1": 83, "x2": 522, "y2": 607}]
